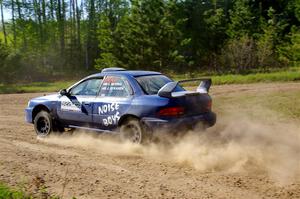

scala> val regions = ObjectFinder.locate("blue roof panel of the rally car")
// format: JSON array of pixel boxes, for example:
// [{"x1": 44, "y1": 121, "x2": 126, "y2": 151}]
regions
[{"x1": 88, "y1": 70, "x2": 161, "y2": 78}]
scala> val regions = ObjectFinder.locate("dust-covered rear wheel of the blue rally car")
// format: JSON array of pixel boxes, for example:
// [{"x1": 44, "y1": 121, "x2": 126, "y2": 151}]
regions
[{"x1": 120, "y1": 118, "x2": 145, "y2": 144}]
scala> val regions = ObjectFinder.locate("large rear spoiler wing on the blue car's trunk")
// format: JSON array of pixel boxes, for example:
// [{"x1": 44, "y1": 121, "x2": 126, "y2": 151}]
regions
[{"x1": 158, "y1": 78, "x2": 212, "y2": 98}]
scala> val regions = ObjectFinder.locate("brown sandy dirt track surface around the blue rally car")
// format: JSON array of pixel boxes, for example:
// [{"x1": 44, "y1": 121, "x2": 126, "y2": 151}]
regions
[{"x1": 0, "y1": 83, "x2": 300, "y2": 198}]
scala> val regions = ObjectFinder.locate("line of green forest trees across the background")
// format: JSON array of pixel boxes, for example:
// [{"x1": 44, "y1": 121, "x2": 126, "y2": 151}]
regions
[{"x1": 0, "y1": 0, "x2": 300, "y2": 82}]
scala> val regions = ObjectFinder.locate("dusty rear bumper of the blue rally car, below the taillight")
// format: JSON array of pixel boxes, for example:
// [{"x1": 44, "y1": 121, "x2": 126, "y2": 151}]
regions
[{"x1": 142, "y1": 112, "x2": 217, "y2": 132}]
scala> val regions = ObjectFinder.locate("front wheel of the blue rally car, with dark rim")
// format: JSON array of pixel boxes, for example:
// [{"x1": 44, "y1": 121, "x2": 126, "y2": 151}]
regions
[{"x1": 34, "y1": 111, "x2": 53, "y2": 137}]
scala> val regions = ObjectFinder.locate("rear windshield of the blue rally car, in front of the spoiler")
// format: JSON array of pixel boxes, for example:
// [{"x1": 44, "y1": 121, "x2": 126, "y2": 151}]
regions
[{"x1": 136, "y1": 75, "x2": 184, "y2": 95}]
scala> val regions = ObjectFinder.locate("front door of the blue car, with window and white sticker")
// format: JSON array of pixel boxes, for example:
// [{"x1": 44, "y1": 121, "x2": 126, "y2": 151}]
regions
[{"x1": 57, "y1": 78, "x2": 102, "y2": 127}]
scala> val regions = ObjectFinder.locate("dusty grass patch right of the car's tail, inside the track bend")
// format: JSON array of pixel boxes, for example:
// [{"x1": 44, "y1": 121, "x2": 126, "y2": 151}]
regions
[{"x1": 212, "y1": 85, "x2": 300, "y2": 123}]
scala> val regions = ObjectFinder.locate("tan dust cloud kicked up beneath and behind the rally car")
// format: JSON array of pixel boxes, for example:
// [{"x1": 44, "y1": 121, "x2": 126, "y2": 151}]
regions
[{"x1": 38, "y1": 109, "x2": 300, "y2": 184}]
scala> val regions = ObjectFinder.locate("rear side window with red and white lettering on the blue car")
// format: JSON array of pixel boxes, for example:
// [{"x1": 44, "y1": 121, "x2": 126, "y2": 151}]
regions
[{"x1": 99, "y1": 76, "x2": 132, "y2": 97}]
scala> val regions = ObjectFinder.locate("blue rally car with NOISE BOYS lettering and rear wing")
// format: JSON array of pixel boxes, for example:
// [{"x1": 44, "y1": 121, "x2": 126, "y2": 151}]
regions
[{"x1": 25, "y1": 68, "x2": 216, "y2": 143}]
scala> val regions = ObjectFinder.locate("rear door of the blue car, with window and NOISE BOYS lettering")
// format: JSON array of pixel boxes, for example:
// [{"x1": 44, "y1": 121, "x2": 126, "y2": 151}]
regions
[{"x1": 93, "y1": 75, "x2": 133, "y2": 130}]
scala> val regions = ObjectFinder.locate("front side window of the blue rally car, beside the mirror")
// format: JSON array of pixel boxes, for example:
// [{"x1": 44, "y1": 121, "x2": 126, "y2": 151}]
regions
[{"x1": 70, "y1": 79, "x2": 102, "y2": 96}]
